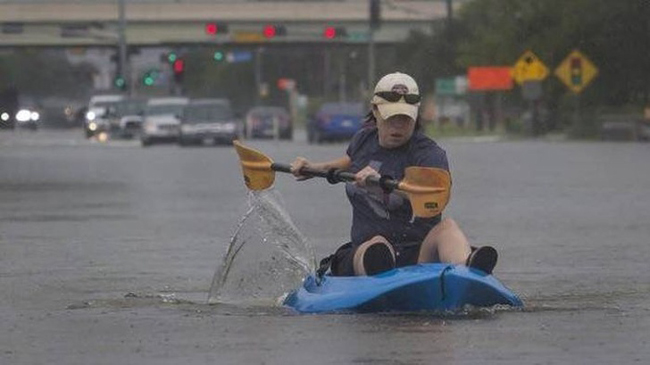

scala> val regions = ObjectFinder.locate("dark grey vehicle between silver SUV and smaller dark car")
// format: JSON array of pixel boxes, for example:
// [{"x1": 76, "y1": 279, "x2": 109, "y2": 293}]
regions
[{"x1": 178, "y1": 99, "x2": 240, "y2": 146}]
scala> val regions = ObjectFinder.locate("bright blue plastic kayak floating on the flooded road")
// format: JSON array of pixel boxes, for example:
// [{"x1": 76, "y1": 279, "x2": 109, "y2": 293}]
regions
[{"x1": 284, "y1": 263, "x2": 523, "y2": 313}]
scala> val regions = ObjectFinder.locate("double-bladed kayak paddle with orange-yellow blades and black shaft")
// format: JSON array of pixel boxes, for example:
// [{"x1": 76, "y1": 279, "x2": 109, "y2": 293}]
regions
[{"x1": 233, "y1": 141, "x2": 451, "y2": 218}]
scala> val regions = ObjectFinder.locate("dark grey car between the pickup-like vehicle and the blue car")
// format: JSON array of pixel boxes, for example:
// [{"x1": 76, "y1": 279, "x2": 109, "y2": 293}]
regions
[{"x1": 244, "y1": 106, "x2": 293, "y2": 140}]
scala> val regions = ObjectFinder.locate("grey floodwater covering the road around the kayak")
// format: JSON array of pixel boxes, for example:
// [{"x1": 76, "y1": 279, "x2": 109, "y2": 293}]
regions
[{"x1": 0, "y1": 130, "x2": 650, "y2": 364}]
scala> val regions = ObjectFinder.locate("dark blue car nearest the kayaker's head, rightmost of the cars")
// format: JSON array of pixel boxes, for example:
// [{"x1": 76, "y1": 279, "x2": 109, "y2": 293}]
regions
[{"x1": 307, "y1": 102, "x2": 364, "y2": 143}]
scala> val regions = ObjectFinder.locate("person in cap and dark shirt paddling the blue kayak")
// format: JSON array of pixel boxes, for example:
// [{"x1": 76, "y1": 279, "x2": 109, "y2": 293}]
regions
[{"x1": 291, "y1": 72, "x2": 498, "y2": 276}]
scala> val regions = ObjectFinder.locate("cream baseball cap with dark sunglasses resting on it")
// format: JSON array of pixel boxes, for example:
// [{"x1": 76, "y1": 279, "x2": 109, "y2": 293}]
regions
[{"x1": 370, "y1": 72, "x2": 420, "y2": 120}]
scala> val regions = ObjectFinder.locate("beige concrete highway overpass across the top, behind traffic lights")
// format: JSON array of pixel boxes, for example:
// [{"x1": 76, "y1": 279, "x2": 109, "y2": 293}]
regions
[{"x1": 0, "y1": 0, "x2": 464, "y2": 47}]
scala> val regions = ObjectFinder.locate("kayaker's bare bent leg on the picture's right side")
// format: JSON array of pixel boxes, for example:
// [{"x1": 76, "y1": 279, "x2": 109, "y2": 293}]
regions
[{"x1": 418, "y1": 218, "x2": 471, "y2": 265}]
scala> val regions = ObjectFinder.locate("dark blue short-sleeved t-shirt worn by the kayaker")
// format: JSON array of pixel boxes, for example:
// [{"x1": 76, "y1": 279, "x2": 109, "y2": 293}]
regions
[{"x1": 345, "y1": 127, "x2": 449, "y2": 245}]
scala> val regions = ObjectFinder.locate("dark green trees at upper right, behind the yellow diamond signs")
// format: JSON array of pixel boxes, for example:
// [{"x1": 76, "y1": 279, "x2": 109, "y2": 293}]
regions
[{"x1": 398, "y1": 0, "x2": 650, "y2": 137}]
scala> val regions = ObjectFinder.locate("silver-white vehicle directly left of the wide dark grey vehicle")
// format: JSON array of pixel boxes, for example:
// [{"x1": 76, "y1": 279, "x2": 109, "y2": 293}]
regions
[{"x1": 140, "y1": 97, "x2": 189, "y2": 147}]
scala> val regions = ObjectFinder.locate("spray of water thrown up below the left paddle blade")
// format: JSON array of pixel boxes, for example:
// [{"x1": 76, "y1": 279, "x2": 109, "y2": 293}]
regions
[{"x1": 208, "y1": 189, "x2": 316, "y2": 305}]
